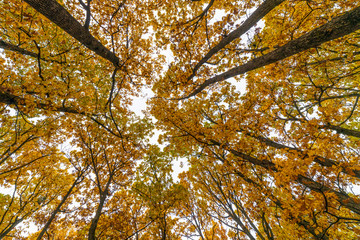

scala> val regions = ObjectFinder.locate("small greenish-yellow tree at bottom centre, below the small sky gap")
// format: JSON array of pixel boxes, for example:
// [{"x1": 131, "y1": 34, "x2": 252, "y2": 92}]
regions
[{"x1": 133, "y1": 146, "x2": 187, "y2": 240}]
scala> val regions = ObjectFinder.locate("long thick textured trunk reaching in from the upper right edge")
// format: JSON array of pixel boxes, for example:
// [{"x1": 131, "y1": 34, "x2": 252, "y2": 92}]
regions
[{"x1": 186, "y1": 7, "x2": 360, "y2": 99}]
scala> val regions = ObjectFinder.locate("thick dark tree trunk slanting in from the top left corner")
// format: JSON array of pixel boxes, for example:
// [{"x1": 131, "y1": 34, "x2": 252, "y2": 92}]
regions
[{"x1": 25, "y1": 0, "x2": 120, "y2": 66}]
